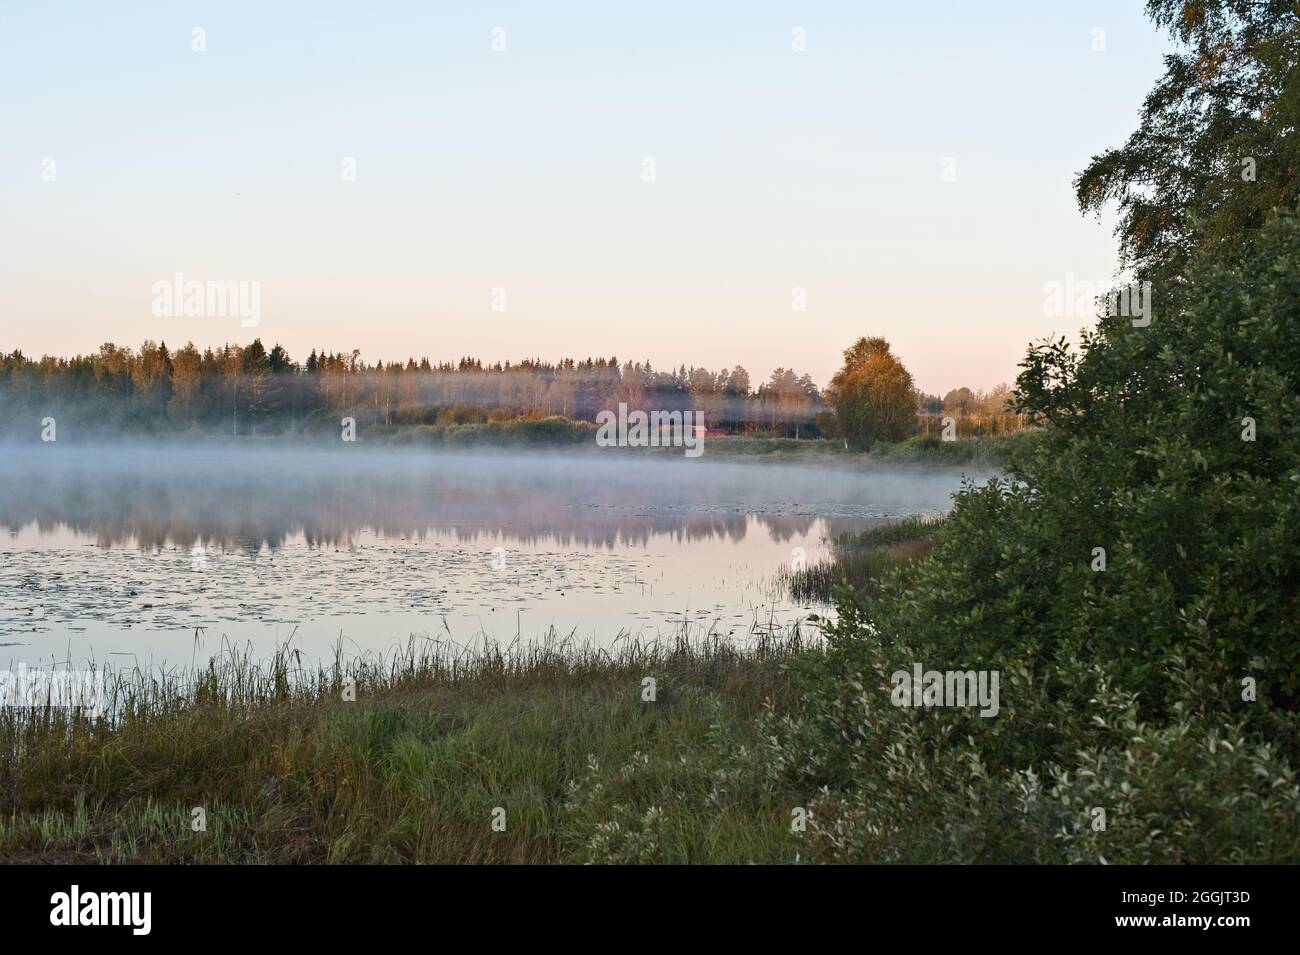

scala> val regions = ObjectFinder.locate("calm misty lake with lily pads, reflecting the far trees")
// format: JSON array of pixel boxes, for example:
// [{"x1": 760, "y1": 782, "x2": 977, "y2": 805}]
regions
[{"x1": 0, "y1": 444, "x2": 977, "y2": 667}]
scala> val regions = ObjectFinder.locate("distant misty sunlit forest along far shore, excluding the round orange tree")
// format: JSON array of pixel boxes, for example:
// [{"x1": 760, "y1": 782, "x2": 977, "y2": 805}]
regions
[{"x1": 0, "y1": 339, "x2": 1008, "y2": 438}]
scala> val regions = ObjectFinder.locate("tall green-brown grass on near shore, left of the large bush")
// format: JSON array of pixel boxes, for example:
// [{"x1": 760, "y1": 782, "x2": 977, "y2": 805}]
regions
[{"x1": 0, "y1": 631, "x2": 806, "y2": 863}]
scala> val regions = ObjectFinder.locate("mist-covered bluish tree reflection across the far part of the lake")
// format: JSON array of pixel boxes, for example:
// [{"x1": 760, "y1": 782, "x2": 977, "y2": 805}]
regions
[{"x1": 0, "y1": 447, "x2": 956, "y2": 554}]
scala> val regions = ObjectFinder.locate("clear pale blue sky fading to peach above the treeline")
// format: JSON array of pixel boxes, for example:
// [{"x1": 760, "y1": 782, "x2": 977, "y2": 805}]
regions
[{"x1": 0, "y1": 0, "x2": 1169, "y2": 394}]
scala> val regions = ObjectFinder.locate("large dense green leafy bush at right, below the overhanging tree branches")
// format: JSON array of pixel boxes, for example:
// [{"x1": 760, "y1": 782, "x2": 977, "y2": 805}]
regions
[{"x1": 771, "y1": 217, "x2": 1300, "y2": 863}]
